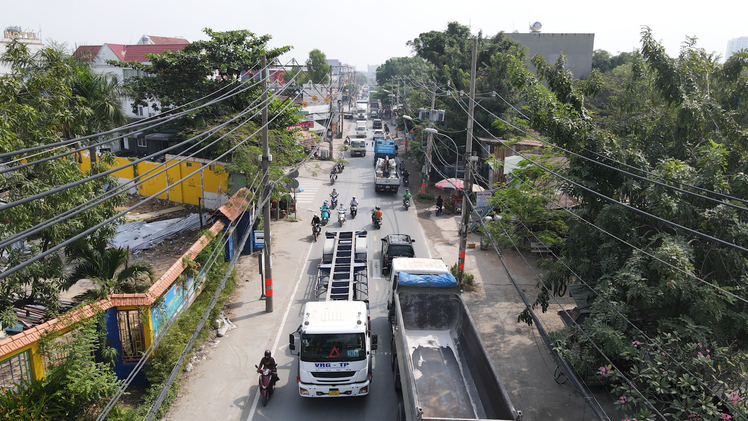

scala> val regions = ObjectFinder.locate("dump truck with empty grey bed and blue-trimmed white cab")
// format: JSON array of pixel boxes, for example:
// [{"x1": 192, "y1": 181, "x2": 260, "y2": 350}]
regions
[{"x1": 387, "y1": 257, "x2": 522, "y2": 421}]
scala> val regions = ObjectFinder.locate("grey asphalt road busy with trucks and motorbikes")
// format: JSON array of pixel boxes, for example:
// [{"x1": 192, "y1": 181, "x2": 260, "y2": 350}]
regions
[{"x1": 168, "y1": 115, "x2": 430, "y2": 421}]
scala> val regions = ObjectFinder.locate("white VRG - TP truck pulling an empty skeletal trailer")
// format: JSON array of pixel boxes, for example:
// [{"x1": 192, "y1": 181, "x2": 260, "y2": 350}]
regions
[{"x1": 289, "y1": 230, "x2": 378, "y2": 398}]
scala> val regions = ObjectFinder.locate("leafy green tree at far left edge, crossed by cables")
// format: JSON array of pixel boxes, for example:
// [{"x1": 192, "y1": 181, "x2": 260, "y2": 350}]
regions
[{"x1": 0, "y1": 41, "x2": 124, "y2": 326}]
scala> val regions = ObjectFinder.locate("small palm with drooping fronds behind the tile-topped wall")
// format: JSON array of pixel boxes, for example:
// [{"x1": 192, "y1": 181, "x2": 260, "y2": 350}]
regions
[{"x1": 63, "y1": 241, "x2": 153, "y2": 302}]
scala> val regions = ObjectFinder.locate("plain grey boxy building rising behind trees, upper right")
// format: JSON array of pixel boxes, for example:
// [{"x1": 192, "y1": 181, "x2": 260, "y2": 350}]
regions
[{"x1": 504, "y1": 31, "x2": 595, "y2": 79}]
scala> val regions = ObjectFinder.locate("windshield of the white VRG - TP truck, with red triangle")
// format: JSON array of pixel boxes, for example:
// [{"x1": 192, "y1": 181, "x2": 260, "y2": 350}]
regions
[{"x1": 300, "y1": 333, "x2": 366, "y2": 363}]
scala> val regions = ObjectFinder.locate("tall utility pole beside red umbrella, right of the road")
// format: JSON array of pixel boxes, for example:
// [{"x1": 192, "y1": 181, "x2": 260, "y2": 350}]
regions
[{"x1": 457, "y1": 37, "x2": 478, "y2": 287}]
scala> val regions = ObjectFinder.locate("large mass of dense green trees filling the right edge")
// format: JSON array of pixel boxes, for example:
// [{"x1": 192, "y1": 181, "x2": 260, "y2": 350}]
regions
[{"x1": 511, "y1": 28, "x2": 748, "y2": 419}]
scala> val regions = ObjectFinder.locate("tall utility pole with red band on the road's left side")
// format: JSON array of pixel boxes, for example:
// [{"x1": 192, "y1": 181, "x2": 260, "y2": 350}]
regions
[{"x1": 262, "y1": 55, "x2": 273, "y2": 313}]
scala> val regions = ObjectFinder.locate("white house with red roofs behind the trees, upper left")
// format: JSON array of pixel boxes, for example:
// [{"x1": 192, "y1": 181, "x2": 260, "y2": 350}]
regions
[{"x1": 73, "y1": 35, "x2": 189, "y2": 118}]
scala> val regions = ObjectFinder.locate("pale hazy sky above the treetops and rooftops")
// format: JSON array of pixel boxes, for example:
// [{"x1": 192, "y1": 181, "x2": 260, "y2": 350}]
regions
[{"x1": 0, "y1": 0, "x2": 748, "y2": 71}]
